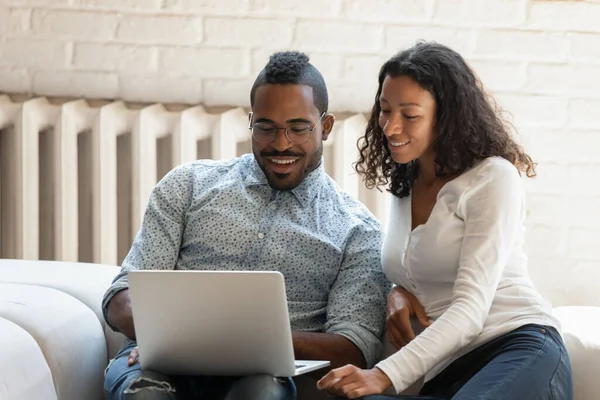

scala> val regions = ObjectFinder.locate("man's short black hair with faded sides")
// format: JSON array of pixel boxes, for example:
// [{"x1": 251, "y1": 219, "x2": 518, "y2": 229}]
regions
[{"x1": 250, "y1": 51, "x2": 329, "y2": 114}]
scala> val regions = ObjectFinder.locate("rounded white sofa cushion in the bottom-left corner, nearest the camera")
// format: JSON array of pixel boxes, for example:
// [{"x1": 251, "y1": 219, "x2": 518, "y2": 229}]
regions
[{"x1": 0, "y1": 318, "x2": 56, "y2": 400}]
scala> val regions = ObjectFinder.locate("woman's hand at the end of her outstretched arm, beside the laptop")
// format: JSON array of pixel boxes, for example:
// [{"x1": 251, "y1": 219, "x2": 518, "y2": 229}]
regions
[{"x1": 317, "y1": 365, "x2": 392, "y2": 399}]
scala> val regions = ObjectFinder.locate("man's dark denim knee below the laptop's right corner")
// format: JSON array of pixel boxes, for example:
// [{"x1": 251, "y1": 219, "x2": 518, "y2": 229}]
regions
[{"x1": 225, "y1": 375, "x2": 296, "y2": 400}]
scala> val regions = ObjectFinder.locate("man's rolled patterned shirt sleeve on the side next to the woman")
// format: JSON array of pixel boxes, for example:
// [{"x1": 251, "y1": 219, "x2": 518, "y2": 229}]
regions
[{"x1": 325, "y1": 214, "x2": 391, "y2": 368}]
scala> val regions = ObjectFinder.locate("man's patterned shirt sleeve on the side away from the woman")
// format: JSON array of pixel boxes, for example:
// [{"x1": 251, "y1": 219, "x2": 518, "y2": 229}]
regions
[{"x1": 102, "y1": 165, "x2": 191, "y2": 330}]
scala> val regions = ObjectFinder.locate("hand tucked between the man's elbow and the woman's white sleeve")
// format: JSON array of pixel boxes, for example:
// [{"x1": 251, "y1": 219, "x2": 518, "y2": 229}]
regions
[{"x1": 386, "y1": 286, "x2": 431, "y2": 349}]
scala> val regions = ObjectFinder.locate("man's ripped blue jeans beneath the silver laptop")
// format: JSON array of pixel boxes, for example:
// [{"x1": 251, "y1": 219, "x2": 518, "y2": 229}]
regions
[{"x1": 104, "y1": 340, "x2": 296, "y2": 400}]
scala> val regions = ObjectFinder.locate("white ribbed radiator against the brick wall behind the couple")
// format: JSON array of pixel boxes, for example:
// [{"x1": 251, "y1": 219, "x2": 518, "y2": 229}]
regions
[{"x1": 0, "y1": 95, "x2": 389, "y2": 265}]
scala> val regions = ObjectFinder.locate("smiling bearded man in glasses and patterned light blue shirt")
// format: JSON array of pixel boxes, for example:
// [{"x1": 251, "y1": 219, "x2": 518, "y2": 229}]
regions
[{"x1": 103, "y1": 52, "x2": 390, "y2": 400}]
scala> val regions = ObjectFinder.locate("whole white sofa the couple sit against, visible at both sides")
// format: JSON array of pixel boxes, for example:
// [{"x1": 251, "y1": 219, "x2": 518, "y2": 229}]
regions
[{"x1": 0, "y1": 260, "x2": 600, "y2": 400}]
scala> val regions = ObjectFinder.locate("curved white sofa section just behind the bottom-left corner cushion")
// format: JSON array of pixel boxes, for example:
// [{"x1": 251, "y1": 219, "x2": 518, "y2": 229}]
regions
[{"x1": 0, "y1": 283, "x2": 107, "y2": 400}]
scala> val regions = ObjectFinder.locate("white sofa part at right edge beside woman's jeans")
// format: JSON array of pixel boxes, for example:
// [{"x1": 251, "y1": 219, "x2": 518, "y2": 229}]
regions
[{"x1": 554, "y1": 306, "x2": 600, "y2": 400}]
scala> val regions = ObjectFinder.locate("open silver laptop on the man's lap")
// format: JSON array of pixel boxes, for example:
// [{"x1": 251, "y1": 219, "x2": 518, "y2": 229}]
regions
[{"x1": 129, "y1": 271, "x2": 330, "y2": 377}]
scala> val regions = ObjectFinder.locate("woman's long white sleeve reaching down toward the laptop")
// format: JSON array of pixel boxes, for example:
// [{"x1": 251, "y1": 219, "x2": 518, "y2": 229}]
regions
[{"x1": 377, "y1": 159, "x2": 525, "y2": 393}]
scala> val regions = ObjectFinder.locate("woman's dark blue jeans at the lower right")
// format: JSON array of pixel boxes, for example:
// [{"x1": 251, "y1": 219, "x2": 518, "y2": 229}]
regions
[{"x1": 352, "y1": 324, "x2": 573, "y2": 400}]
